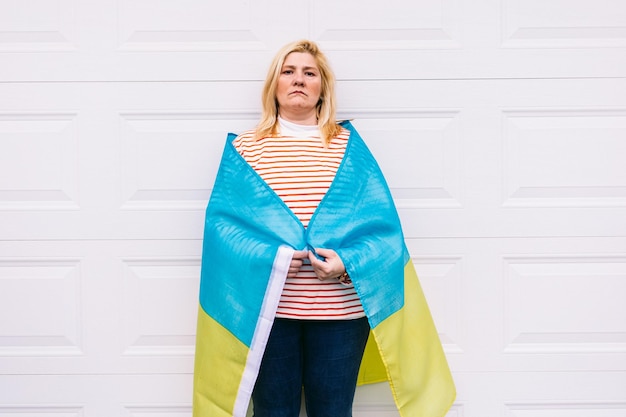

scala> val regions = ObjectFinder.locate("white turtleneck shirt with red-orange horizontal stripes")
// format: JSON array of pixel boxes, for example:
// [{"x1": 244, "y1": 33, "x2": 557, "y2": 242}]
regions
[{"x1": 234, "y1": 119, "x2": 365, "y2": 320}]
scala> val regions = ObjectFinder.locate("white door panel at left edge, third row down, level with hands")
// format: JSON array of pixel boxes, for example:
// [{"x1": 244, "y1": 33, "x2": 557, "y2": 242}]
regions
[{"x1": 0, "y1": 259, "x2": 82, "y2": 356}]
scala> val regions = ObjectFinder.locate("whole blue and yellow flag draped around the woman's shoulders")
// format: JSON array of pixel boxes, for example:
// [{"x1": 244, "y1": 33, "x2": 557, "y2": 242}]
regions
[{"x1": 193, "y1": 122, "x2": 455, "y2": 417}]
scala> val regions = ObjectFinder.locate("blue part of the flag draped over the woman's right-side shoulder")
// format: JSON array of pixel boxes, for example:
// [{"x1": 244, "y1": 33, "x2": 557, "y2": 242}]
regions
[{"x1": 306, "y1": 122, "x2": 408, "y2": 327}]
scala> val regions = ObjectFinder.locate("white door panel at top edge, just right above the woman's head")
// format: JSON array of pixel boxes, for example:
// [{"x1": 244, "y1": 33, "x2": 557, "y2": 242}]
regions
[{"x1": 311, "y1": 0, "x2": 460, "y2": 50}]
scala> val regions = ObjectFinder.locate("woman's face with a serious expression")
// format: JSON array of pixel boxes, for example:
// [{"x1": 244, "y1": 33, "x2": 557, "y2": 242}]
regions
[{"x1": 276, "y1": 52, "x2": 322, "y2": 125}]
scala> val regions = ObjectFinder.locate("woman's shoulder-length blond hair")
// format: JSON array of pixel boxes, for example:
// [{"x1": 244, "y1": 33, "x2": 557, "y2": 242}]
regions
[{"x1": 255, "y1": 40, "x2": 341, "y2": 145}]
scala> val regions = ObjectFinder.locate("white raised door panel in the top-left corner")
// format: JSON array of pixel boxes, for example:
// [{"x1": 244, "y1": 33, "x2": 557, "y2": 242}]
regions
[{"x1": 0, "y1": 0, "x2": 76, "y2": 52}]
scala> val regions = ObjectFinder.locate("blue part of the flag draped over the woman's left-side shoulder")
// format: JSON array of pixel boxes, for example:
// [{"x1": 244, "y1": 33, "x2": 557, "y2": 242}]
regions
[{"x1": 200, "y1": 134, "x2": 305, "y2": 346}]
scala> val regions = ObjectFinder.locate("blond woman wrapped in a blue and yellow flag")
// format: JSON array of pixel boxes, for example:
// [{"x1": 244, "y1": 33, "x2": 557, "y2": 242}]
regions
[{"x1": 194, "y1": 41, "x2": 454, "y2": 417}]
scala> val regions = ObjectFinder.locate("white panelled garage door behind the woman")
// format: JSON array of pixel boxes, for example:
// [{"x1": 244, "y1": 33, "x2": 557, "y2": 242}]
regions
[{"x1": 0, "y1": 0, "x2": 626, "y2": 417}]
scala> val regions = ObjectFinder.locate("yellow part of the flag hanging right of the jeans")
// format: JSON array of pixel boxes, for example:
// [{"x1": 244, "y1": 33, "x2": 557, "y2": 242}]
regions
[{"x1": 359, "y1": 259, "x2": 456, "y2": 417}]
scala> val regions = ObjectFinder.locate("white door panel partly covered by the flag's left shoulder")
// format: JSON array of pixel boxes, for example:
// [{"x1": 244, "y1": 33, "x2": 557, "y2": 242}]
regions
[{"x1": 121, "y1": 113, "x2": 255, "y2": 210}]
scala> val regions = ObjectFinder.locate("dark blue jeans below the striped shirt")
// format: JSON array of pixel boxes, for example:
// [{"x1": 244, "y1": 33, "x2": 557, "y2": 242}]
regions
[{"x1": 252, "y1": 318, "x2": 370, "y2": 417}]
